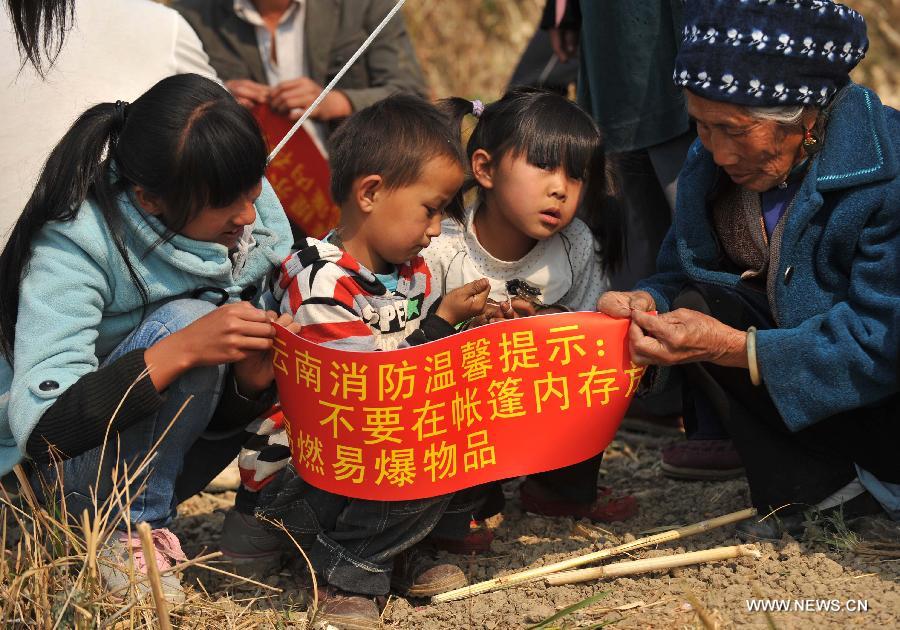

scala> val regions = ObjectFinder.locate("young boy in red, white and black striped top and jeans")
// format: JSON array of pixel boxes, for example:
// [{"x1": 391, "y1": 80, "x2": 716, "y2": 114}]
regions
[{"x1": 222, "y1": 95, "x2": 490, "y2": 627}]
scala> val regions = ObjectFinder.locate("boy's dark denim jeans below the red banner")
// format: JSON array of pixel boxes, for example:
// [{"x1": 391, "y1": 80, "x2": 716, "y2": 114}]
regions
[{"x1": 257, "y1": 465, "x2": 453, "y2": 596}]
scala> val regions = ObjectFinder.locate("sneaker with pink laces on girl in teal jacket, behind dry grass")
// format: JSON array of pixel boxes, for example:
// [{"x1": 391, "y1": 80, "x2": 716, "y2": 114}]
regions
[{"x1": 100, "y1": 527, "x2": 187, "y2": 604}]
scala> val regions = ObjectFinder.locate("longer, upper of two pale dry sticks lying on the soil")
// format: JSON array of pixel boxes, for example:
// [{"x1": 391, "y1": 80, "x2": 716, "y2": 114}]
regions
[{"x1": 431, "y1": 508, "x2": 756, "y2": 604}]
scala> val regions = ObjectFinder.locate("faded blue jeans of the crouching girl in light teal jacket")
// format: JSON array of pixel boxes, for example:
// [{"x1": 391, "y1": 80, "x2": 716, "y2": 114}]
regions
[{"x1": 63, "y1": 299, "x2": 227, "y2": 529}]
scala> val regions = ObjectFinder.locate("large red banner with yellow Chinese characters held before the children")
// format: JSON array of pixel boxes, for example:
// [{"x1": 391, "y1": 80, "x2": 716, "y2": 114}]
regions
[{"x1": 274, "y1": 313, "x2": 644, "y2": 501}]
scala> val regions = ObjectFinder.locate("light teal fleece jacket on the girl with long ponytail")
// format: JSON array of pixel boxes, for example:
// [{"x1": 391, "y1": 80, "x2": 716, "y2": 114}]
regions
[{"x1": 0, "y1": 181, "x2": 291, "y2": 474}]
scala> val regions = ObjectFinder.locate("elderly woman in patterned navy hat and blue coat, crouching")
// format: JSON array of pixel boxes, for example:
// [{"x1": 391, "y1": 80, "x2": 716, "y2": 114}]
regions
[{"x1": 598, "y1": 0, "x2": 900, "y2": 539}]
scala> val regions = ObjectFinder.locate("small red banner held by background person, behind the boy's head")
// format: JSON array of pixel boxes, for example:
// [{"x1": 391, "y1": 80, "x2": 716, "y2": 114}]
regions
[{"x1": 253, "y1": 105, "x2": 340, "y2": 238}]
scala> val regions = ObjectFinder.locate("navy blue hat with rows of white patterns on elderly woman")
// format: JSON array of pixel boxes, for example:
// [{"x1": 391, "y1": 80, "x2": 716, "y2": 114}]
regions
[{"x1": 674, "y1": 0, "x2": 869, "y2": 107}]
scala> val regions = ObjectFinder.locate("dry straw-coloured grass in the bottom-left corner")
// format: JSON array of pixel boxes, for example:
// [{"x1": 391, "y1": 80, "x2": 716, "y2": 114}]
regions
[{"x1": 0, "y1": 388, "x2": 316, "y2": 630}]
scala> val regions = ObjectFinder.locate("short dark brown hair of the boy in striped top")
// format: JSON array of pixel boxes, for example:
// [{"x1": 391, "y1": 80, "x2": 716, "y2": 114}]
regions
[{"x1": 328, "y1": 94, "x2": 466, "y2": 205}]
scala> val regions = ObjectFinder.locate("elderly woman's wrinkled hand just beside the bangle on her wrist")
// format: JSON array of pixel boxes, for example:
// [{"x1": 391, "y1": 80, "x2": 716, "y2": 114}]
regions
[{"x1": 628, "y1": 308, "x2": 747, "y2": 367}]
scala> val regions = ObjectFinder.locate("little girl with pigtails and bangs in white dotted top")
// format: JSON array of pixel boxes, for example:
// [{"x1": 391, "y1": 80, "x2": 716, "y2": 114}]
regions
[{"x1": 422, "y1": 88, "x2": 637, "y2": 536}]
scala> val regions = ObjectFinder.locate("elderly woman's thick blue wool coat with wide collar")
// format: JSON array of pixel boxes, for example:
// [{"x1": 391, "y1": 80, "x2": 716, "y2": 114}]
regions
[{"x1": 638, "y1": 85, "x2": 900, "y2": 431}]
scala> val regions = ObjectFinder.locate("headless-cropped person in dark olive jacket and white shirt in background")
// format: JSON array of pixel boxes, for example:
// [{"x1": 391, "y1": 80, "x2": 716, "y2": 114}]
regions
[{"x1": 172, "y1": 0, "x2": 425, "y2": 139}]
